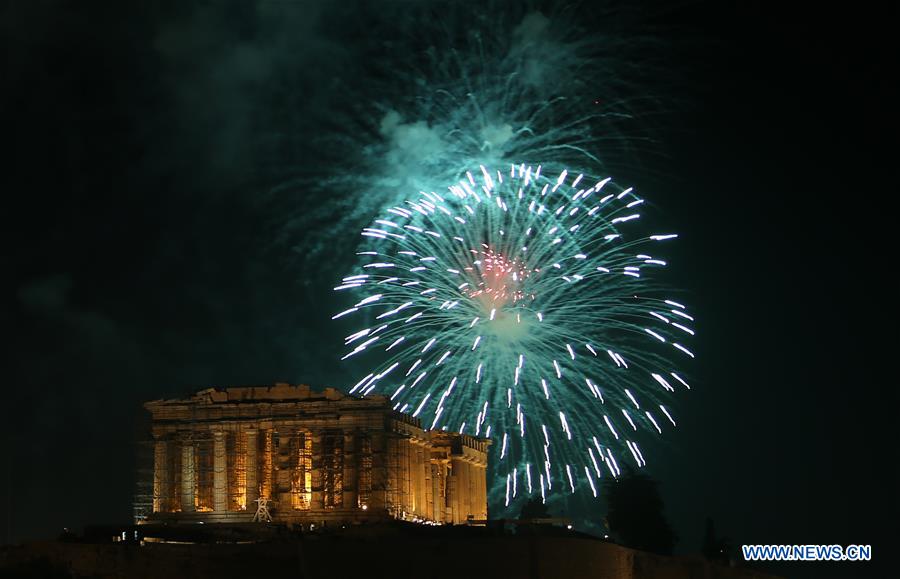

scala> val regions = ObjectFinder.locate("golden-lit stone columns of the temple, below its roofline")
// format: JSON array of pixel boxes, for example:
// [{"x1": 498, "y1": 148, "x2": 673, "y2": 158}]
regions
[{"x1": 154, "y1": 428, "x2": 487, "y2": 524}]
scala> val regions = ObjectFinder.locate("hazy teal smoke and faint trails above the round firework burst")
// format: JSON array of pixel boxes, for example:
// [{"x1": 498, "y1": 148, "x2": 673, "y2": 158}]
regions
[{"x1": 276, "y1": 2, "x2": 655, "y2": 270}]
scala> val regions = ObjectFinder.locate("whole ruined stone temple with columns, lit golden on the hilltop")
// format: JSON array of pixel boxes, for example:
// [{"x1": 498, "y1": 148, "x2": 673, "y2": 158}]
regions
[{"x1": 138, "y1": 384, "x2": 489, "y2": 526}]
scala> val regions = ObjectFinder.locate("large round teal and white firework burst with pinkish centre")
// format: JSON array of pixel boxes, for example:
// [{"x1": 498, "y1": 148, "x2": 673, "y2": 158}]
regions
[{"x1": 334, "y1": 164, "x2": 694, "y2": 506}]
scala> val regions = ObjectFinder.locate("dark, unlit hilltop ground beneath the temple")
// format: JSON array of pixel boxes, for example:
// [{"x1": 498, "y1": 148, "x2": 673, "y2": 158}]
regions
[{"x1": 0, "y1": 524, "x2": 772, "y2": 579}]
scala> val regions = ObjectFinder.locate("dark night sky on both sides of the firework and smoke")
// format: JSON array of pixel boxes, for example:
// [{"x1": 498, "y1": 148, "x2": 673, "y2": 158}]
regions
[{"x1": 0, "y1": 0, "x2": 898, "y2": 576}]
